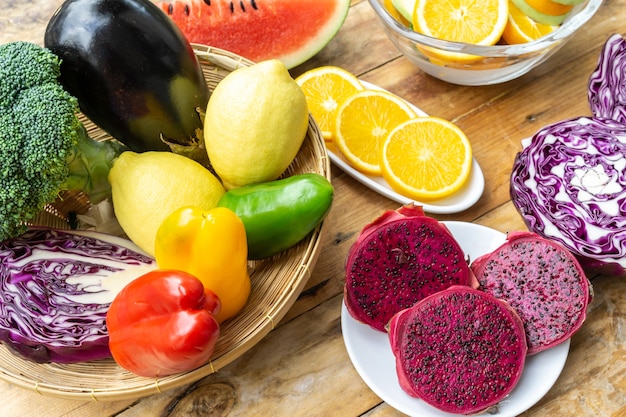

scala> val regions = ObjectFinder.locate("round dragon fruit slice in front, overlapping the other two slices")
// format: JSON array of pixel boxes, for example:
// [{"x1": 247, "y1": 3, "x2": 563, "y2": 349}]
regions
[{"x1": 389, "y1": 285, "x2": 527, "y2": 414}]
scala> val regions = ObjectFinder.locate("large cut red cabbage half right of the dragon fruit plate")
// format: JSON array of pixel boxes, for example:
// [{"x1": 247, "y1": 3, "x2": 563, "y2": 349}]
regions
[{"x1": 510, "y1": 117, "x2": 626, "y2": 275}]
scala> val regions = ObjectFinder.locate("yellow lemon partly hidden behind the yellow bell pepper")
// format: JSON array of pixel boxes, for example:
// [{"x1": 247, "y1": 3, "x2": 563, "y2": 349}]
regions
[{"x1": 109, "y1": 151, "x2": 225, "y2": 256}]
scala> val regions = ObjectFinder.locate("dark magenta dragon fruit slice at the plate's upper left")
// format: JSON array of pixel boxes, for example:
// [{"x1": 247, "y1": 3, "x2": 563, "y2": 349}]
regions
[{"x1": 344, "y1": 204, "x2": 478, "y2": 332}]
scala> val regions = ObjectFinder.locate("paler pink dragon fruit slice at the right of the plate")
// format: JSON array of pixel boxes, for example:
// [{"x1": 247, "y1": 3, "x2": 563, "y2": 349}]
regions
[{"x1": 471, "y1": 231, "x2": 592, "y2": 355}]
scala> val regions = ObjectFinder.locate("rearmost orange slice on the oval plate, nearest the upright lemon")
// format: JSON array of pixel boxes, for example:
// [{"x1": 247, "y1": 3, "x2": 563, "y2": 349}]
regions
[{"x1": 296, "y1": 66, "x2": 365, "y2": 141}]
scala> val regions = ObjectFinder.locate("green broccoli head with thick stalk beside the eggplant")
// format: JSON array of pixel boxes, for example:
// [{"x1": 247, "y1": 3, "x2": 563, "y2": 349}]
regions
[{"x1": 0, "y1": 41, "x2": 125, "y2": 241}]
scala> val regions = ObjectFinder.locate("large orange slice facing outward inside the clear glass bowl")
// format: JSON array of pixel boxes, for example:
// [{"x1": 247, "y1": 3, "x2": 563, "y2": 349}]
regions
[{"x1": 412, "y1": 0, "x2": 509, "y2": 61}]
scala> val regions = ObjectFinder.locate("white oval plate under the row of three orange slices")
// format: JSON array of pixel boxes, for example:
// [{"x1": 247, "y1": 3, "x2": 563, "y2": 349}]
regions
[{"x1": 327, "y1": 80, "x2": 485, "y2": 214}]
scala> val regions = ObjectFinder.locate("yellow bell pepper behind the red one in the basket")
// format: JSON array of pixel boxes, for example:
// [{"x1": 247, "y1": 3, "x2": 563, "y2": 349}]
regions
[{"x1": 155, "y1": 207, "x2": 250, "y2": 323}]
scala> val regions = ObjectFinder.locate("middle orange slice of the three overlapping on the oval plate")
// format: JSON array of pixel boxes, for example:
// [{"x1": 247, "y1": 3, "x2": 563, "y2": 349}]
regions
[{"x1": 335, "y1": 90, "x2": 417, "y2": 175}]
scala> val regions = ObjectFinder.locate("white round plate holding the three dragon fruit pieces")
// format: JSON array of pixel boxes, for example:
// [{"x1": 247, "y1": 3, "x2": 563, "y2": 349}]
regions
[{"x1": 341, "y1": 222, "x2": 570, "y2": 417}]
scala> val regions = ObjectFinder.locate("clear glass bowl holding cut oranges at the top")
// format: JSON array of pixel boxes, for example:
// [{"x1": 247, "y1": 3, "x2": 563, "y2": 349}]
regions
[{"x1": 368, "y1": 0, "x2": 602, "y2": 86}]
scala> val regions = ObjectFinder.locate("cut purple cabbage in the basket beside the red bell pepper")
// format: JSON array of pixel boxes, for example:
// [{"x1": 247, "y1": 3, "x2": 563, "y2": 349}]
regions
[{"x1": 0, "y1": 229, "x2": 156, "y2": 363}]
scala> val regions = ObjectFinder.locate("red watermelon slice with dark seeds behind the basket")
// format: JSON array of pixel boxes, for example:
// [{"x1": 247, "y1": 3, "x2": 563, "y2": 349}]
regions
[{"x1": 155, "y1": 0, "x2": 350, "y2": 68}]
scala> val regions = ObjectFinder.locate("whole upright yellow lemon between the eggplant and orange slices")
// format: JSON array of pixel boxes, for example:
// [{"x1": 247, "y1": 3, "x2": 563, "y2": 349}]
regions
[{"x1": 204, "y1": 59, "x2": 309, "y2": 189}]
